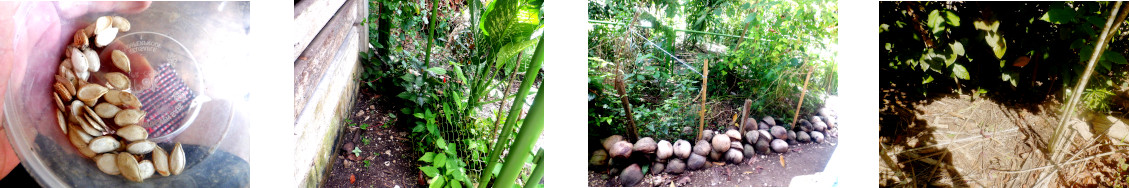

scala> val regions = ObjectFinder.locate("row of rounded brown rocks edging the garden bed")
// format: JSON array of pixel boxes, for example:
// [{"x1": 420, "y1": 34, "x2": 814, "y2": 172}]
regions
[{"x1": 588, "y1": 108, "x2": 838, "y2": 186}]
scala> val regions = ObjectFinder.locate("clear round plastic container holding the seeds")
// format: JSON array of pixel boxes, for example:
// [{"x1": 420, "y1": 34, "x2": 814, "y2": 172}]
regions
[{"x1": 3, "y1": 2, "x2": 250, "y2": 187}]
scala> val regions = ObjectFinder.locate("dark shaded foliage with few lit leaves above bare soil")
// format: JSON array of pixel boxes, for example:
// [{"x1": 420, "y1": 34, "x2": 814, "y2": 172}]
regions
[{"x1": 878, "y1": 2, "x2": 1129, "y2": 113}]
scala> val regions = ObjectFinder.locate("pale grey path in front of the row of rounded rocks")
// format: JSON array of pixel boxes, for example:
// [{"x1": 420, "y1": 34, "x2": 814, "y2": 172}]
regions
[{"x1": 588, "y1": 137, "x2": 839, "y2": 187}]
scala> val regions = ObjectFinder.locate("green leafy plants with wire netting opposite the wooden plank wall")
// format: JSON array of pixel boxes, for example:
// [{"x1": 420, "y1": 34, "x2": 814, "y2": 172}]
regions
[{"x1": 359, "y1": 0, "x2": 544, "y2": 187}]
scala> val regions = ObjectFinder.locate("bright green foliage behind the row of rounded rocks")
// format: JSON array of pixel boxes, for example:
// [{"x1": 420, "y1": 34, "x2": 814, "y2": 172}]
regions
[{"x1": 588, "y1": 0, "x2": 838, "y2": 138}]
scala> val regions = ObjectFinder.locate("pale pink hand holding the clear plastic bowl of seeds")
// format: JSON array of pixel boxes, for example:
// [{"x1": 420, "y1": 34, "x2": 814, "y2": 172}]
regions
[{"x1": 0, "y1": 2, "x2": 150, "y2": 178}]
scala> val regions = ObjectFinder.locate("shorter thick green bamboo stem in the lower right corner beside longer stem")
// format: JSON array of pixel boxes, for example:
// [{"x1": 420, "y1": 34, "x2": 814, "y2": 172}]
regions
[{"x1": 494, "y1": 82, "x2": 545, "y2": 187}]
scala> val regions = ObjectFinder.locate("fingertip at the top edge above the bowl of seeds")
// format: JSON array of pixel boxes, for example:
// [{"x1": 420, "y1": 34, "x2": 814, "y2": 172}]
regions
[{"x1": 56, "y1": 1, "x2": 152, "y2": 18}]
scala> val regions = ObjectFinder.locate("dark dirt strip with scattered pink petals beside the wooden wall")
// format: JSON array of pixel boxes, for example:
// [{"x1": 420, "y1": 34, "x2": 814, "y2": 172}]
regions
[{"x1": 324, "y1": 89, "x2": 422, "y2": 188}]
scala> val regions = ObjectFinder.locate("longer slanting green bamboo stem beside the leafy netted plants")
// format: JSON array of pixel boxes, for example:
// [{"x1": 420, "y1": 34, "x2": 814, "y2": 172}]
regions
[{"x1": 479, "y1": 37, "x2": 545, "y2": 188}]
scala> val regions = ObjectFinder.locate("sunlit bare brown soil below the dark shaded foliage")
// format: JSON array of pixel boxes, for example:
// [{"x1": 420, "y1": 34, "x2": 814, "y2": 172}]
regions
[{"x1": 878, "y1": 90, "x2": 1127, "y2": 187}]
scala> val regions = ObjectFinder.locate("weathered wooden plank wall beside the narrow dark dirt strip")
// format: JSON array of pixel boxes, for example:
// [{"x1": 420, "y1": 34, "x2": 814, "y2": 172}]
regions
[{"x1": 292, "y1": 0, "x2": 369, "y2": 187}]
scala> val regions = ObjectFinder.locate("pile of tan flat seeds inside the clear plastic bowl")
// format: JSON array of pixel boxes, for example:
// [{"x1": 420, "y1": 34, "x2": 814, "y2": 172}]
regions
[{"x1": 52, "y1": 16, "x2": 185, "y2": 182}]
